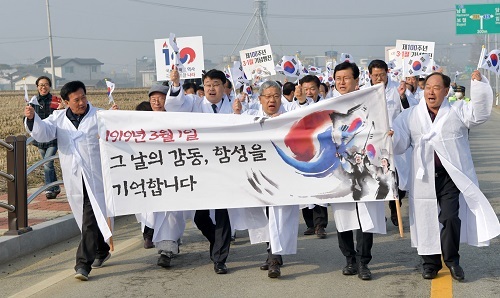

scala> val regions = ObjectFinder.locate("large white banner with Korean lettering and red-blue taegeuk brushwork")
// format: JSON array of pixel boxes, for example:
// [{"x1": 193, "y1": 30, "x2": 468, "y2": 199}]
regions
[{"x1": 98, "y1": 85, "x2": 396, "y2": 216}]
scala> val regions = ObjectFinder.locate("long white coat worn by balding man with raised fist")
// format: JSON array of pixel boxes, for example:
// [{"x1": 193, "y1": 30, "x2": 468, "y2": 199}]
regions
[{"x1": 393, "y1": 76, "x2": 500, "y2": 255}]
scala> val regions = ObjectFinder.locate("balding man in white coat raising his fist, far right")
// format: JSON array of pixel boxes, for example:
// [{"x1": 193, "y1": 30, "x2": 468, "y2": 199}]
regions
[{"x1": 393, "y1": 70, "x2": 500, "y2": 281}]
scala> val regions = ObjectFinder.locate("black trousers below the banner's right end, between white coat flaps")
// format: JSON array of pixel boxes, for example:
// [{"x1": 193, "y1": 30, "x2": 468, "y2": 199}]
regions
[{"x1": 337, "y1": 204, "x2": 373, "y2": 264}]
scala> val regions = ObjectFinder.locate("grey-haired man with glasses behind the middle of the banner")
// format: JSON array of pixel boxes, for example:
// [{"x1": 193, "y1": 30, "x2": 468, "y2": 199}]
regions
[{"x1": 233, "y1": 81, "x2": 299, "y2": 278}]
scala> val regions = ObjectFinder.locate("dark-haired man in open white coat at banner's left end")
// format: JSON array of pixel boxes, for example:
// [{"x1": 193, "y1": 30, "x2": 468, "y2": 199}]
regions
[{"x1": 24, "y1": 81, "x2": 113, "y2": 281}]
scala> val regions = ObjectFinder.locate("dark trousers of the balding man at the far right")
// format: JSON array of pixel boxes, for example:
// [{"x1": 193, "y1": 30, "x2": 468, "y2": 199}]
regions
[{"x1": 422, "y1": 170, "x2": 461, "y2": 270}]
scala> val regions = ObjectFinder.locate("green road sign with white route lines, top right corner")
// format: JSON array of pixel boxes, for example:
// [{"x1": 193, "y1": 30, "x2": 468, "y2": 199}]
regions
[{"x1": 455, "y1": 3, "x2": 500, "y2": 34}]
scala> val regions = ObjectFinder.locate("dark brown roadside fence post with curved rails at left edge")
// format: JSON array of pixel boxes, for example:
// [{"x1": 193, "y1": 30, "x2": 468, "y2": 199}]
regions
[{"x1": 0, "y1": 135, "x2": 63, "y2": 235}]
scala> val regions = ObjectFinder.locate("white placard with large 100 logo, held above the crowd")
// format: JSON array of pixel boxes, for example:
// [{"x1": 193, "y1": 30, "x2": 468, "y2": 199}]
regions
[{"x1": 154, "y1": 36, "x2": 205, "y2": 81}]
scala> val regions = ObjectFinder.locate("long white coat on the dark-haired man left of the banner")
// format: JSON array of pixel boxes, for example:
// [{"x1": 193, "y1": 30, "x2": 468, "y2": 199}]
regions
[{"x1": 26, "y1": 103, "x2": 111, "y2": 240}]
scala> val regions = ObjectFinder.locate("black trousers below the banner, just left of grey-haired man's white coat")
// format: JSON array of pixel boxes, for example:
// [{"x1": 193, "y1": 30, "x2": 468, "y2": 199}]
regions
[{"x1": 194, "y1": 209, "x2": 231, "y2": 263}]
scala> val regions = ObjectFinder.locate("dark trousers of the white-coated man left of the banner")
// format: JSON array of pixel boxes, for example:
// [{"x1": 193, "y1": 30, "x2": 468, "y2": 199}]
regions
[{"x1": 75, "y1": 184, "x2": 109, "y2": 272}]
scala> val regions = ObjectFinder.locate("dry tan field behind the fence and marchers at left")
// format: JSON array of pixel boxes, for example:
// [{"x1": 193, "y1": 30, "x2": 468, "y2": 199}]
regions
[{"x1": 0, "y1": 88, "x2": 148, "y2": 194}]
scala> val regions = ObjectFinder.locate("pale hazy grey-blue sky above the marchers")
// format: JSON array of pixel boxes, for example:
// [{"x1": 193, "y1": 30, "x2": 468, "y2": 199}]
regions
[{"x1": 0, "y1": 0, "x2": 499, "y2": 72}]
